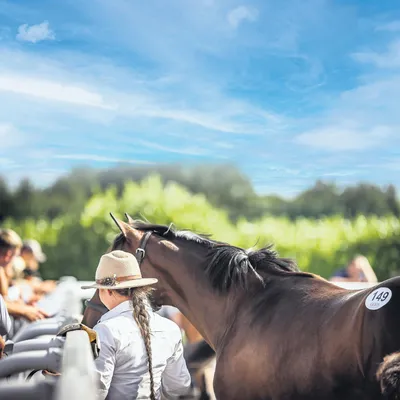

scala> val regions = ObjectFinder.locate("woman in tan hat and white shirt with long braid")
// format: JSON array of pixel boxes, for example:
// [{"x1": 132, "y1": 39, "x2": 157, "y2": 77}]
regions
[{"x1": 82, "y1": 250, "x2": 192, "y2": 400}]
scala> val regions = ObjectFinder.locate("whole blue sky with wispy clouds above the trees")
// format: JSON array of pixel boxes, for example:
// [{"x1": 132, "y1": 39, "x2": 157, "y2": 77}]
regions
[{"x1": 0, "y1": 0, "x2": 400, "y2": 196}]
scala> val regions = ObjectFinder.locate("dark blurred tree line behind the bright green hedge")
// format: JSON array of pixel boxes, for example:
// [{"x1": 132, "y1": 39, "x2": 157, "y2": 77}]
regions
[{"x1": 0, "y1": 164, "x2": 400, "y2": 222}]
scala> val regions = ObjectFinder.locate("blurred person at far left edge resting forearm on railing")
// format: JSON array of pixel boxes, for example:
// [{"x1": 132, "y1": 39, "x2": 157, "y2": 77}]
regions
[{"x1": 0, "y1": 229, "x2": 48, "y2": 321}]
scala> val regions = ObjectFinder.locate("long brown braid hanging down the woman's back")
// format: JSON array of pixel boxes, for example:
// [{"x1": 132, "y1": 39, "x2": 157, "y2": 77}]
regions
[{"x1": 116, "y1": 287, "x2": 156, "y2": 400}]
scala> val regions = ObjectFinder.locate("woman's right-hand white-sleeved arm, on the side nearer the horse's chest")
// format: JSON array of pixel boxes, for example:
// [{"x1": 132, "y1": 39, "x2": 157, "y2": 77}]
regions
[{"x1": 161, "y1": 332, "x2": 192, "y2": 399}]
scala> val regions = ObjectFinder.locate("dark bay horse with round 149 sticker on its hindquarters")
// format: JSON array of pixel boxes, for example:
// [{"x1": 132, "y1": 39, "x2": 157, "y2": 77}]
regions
[{"x1": 85, "y1": 214, "x2": 400, "y2": 400}]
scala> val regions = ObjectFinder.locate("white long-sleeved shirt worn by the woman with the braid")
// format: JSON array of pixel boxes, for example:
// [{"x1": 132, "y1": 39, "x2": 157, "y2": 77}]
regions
[{"x1": 93, "y1": 301, "x2": 191, "y2": 400}]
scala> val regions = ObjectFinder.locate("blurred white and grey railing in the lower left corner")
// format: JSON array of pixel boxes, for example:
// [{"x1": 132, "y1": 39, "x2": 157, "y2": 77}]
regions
[{"x1": 0, "y1": 277, "x2": 97, "y2": 400}]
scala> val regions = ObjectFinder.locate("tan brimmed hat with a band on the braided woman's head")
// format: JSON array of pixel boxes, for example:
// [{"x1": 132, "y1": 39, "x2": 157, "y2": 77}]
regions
[{"x1": 81, "y1": 250, "x2": 158, "y2": 289}]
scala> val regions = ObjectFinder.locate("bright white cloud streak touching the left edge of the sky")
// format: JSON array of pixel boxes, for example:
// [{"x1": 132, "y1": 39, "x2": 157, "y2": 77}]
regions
[{"x1": 0, "y1": 73, "x2": 115, "y2": 109}]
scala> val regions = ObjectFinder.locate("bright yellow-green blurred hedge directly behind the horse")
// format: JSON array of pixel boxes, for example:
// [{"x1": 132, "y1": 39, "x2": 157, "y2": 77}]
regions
[{"x1": 5, "y1": 175, "x2": 400, "y2": 280}]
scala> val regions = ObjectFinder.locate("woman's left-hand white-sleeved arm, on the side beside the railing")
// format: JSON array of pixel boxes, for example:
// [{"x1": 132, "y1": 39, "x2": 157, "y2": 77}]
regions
[{"x1": 93, "y1": 324, "x2": 117, "y2": 400}]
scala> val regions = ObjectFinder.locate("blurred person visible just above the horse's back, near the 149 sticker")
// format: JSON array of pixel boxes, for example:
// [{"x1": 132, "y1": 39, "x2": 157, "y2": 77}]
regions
[{"x1": 330, "y1": 255, "x2": 378, "y2": 283}]
